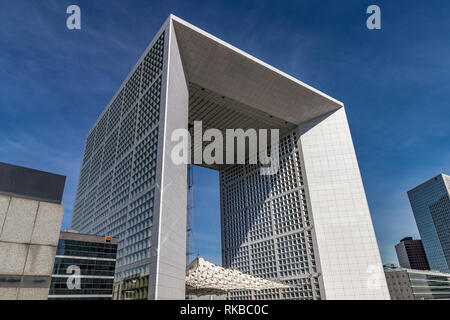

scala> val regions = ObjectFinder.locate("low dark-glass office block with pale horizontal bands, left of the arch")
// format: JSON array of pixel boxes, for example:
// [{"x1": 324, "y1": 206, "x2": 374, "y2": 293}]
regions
[{"x1": 48, "y1": 229, "x2": 118, "y2": 300}]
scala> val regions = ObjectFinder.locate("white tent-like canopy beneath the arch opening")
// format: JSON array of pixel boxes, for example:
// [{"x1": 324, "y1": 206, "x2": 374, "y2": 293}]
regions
[{"x1": 186, "y1": 257, "x2": 290, "y2": 296}]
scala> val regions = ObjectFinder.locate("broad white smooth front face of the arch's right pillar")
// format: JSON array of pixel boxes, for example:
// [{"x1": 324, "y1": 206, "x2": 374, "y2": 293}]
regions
[{"x1": 299, "y1": 108, "x2": 389, "y2": 300}]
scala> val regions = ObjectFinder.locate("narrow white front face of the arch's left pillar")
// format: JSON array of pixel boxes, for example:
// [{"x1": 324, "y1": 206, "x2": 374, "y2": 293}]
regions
[{"x1": 149, "y1": 18, "x2": 189, "y2": 299}]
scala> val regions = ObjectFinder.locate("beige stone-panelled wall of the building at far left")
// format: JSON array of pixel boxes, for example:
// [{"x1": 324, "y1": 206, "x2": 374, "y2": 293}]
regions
[{"x1": 0, "y1": 194, "x2": 64, "y2": 300}]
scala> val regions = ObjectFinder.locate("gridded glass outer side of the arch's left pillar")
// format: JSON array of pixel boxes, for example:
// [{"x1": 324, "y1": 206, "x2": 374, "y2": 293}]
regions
[{"x1": 71, "y1": 32, "x2": 165, "y2": 298}]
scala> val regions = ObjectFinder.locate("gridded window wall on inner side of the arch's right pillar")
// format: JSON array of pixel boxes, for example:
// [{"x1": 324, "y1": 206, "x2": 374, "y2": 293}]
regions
[{"x1": 220, "y1": 131, "x2": 320, "y2": 299}]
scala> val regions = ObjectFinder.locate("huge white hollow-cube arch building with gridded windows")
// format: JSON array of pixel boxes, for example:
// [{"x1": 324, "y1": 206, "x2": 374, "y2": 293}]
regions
[{"x1": 72, "y1": 15, "x2": 389, "y2": 299}]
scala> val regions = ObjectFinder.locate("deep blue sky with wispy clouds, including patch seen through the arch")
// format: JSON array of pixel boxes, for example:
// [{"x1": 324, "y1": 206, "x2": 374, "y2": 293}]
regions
[{"x1": 0, "y1": 0, "x2": 450, "y2": 262}]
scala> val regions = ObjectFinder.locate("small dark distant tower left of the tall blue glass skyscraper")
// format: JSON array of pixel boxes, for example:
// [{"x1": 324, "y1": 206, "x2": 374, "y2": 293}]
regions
[{"x1": 395, "y1": 237, "x2": 430, "y2": 270}]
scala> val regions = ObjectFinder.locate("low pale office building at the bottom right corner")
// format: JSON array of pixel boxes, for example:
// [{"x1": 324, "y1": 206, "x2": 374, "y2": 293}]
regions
[{"x1": 385, "y1": 268, "x2": 450, "y2": 300}]
